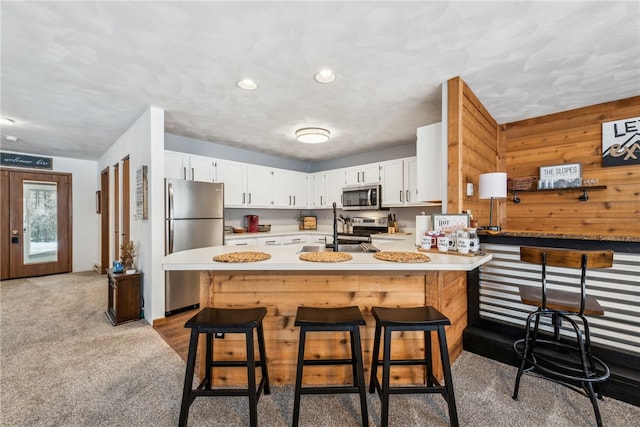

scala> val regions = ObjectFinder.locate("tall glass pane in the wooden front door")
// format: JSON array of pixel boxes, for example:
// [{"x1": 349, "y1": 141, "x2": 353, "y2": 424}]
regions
[{"x1": 22, "y1": 181, "x2": 58, "y2": 264}]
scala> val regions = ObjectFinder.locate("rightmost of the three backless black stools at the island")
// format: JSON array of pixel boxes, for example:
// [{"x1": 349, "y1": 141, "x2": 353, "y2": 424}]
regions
[{"x1": 369, "y1": 306, "x2": 458, "y2": 427}]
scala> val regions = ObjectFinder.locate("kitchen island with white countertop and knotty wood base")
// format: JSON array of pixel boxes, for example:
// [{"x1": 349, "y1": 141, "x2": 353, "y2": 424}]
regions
[{"x1": 163, "y1": 236, "x2": 491, "y2": 384}]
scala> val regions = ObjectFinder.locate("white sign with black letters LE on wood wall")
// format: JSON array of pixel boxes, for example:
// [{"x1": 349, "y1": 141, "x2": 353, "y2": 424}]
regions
[{"x1": 602, "y1": 117, "x2": 640, "y2": 167}]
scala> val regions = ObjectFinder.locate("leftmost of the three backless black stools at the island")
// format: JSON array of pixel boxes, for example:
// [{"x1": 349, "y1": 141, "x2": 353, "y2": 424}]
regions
[{"x1": 179, "y1": 307, "x2": 271, "y2": 427}]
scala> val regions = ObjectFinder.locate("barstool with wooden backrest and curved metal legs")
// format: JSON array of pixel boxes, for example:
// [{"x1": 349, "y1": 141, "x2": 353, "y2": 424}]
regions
[{"x1": 513, "y1": 246, "x2": 613, "y2": 426}]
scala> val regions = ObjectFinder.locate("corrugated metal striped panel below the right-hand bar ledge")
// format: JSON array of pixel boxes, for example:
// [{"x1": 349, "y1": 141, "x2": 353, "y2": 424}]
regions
[{"x1": 480, "y1": 243, "x2": 640, "y2": 355}]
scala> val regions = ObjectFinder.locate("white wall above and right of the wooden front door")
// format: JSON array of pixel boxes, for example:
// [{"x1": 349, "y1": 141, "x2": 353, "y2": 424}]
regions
[{"x1": 1, "y1": 153, "x2": 100, "y2": 272}]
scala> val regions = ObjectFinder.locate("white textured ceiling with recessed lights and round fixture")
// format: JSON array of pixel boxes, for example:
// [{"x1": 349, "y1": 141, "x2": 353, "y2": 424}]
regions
[{"x1": 0, "y1": 1, "x2": 640, "y2": 161}]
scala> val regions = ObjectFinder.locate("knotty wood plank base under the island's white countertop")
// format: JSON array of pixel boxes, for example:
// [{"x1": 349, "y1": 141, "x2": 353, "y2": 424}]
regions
[{"x1": 199, "y1": 270, "x2": 467, "y2": 385}]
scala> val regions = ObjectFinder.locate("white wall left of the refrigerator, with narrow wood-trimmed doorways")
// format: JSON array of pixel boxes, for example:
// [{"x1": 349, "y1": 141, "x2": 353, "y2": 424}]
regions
[{"x1": 94, "y1": 107, "x2": 164, "y2": 323}]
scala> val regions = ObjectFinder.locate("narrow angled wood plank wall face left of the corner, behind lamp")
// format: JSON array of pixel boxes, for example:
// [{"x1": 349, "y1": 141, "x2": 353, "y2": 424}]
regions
[{"x1": 447, "y1": 77, "x2": 505, "y2": 225}]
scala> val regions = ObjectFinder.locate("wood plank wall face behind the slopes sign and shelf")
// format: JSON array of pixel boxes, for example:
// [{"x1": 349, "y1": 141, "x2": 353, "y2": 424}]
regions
[{"x1": 499, "y1": 96, "x2": 640, "y2": 236}]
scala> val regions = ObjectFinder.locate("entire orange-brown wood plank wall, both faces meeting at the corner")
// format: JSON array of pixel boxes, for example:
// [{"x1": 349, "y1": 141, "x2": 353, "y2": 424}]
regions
[{"x1": 447, "y1": 77, "x2": 640, "y2": 237}]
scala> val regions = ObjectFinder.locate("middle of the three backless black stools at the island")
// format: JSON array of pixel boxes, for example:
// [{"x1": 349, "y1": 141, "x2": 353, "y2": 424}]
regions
[{"x1": 293, "y1": 307, "x2": 369, "y2": 427}]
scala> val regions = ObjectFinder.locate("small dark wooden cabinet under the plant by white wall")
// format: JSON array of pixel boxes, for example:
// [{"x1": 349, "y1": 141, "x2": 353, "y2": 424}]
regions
[{"x1": 107, "y1": 268, "x2": 142, "y2": 326}]
